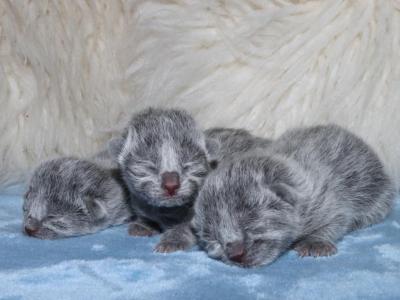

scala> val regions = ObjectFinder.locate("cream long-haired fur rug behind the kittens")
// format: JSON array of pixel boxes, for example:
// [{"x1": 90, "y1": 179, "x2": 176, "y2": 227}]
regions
[{"x1": 0, "y1": 0, "x2": 400, "y2": 185}]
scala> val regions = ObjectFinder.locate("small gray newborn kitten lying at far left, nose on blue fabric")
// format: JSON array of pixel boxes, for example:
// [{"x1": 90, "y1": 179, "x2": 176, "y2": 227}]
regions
[{"x1": 23, "y1": 157, "x2": 132, "y2": 239}]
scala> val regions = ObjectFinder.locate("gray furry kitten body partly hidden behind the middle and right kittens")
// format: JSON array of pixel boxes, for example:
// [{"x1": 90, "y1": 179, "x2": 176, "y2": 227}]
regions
[{"x1": 204, "y1": 127, "x2": 271, "y2": 169}]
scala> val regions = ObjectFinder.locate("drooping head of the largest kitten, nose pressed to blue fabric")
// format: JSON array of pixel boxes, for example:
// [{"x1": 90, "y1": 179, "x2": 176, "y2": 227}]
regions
[{"x1": 193, "y1": 157, "x2": 297, "y2": 267}]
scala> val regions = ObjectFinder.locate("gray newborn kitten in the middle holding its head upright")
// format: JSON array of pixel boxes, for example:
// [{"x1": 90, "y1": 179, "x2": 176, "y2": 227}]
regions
[{"x1": 113, "y1": 108, "x2": 209, "y2": 252}]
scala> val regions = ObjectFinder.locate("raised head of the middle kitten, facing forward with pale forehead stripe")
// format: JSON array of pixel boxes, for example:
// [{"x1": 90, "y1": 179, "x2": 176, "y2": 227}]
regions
[{"x1": 117, "y1": 108, "x2": 208, "y2": 207}]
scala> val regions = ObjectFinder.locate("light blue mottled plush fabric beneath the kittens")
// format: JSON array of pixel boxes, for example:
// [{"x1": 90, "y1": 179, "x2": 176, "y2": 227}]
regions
[{"x1": 0, "y1": 189, "x2": 400, "y2": 300}]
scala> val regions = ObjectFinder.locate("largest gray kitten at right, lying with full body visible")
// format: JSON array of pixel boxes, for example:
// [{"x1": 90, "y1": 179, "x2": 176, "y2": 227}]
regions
[{"x1": 193, "y1": 125, "x2": 394, "y2": 267}]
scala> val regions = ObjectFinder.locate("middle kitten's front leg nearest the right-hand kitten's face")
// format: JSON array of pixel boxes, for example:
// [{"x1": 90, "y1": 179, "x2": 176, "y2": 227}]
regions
[{"x1": 154, "y1": 223, "x2": 196, "y2": 253}]
